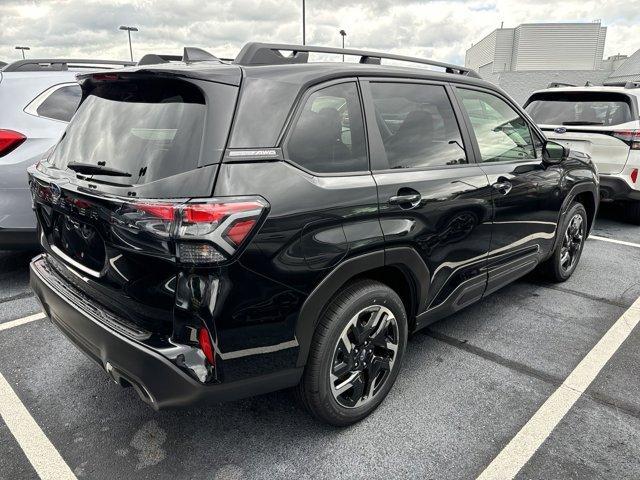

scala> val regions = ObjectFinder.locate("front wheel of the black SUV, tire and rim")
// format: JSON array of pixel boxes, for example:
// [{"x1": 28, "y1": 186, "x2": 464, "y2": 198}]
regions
[{"x1": 540, "y1": 202, "x2": 588, "y2": 283}]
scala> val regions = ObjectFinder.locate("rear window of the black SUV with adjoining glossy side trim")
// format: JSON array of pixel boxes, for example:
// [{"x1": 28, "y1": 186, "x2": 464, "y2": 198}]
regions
[{"x1": 50, "y1": 79, "x2": 235, "y2": 185}]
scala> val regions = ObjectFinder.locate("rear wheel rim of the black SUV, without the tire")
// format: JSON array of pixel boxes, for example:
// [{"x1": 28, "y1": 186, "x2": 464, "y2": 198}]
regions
[{"x1": 329, "y1": 305, "x2": 400, "y2": 408}]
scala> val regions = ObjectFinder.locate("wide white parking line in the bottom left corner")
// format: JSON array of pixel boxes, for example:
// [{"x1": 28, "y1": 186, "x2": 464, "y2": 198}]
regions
[{"x1": 0, "y1": 373, "x2": 76, "y2": 480}]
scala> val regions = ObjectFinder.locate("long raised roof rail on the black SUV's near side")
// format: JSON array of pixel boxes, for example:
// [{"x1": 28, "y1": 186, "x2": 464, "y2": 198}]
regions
[{"x1": 234, "y1": 42, "x2": 480, "y2": 78}]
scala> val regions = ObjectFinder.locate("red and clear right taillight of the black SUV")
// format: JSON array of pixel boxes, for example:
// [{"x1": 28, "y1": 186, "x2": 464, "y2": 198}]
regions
[{"x1": 120, "y1": 198, "x2": 267, "y2": 265}]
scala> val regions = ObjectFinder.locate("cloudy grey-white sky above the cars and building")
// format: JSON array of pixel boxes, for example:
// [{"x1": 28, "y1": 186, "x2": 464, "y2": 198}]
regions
[{"x1": 0, "y1": 0, "x2": 640, "y2": 63}]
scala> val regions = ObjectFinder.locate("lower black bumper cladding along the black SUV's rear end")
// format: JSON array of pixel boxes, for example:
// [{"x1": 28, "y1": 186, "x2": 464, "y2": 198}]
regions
[{"x1": 30, "y1": 255, "x2": 302, "y2": 410}]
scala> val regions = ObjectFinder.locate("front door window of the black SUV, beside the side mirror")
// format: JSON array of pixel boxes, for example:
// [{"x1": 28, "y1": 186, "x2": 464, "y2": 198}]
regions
[{"x1": 458, "y1": 88, "x2": 540, "y2": 162}]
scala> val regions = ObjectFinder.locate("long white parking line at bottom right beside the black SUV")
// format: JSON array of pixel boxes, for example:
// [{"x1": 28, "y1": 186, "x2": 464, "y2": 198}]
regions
[{"x1": 478, "y1": 298, "x2": 640, "y2": 480}]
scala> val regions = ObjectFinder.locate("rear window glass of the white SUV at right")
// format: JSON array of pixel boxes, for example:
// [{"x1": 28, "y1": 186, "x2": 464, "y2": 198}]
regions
[{"x1": 526, "y1": 92, "x2": 633, "y2": 126}]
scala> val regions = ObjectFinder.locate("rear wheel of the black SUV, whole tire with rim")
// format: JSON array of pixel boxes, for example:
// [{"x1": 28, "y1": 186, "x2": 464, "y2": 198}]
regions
[{"x1": 297, "y1": 280, "x2": 407, "y2": 427}]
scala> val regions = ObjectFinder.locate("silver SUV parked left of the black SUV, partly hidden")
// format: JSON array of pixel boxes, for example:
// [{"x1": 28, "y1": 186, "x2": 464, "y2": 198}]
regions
[{"x1": 0, "y1": 59, "x2": 133, "y2": 250}]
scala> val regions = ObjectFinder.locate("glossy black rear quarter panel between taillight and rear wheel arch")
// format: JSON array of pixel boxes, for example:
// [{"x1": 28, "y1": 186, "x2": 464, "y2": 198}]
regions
[{"x1": 213, "y1": 161, "x2": 383, "y2": 379}]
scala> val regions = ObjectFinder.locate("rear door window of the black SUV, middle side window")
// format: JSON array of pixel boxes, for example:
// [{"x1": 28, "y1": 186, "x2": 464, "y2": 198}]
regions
[{"x1": 371, "y1": 83, "x2": 468, "y2": 168}]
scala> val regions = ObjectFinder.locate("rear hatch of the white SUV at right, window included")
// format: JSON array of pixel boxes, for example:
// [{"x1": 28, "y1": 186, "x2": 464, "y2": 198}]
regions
[{"x1": 525, "y1": 91, "x2": 637, "y2": 174}]
